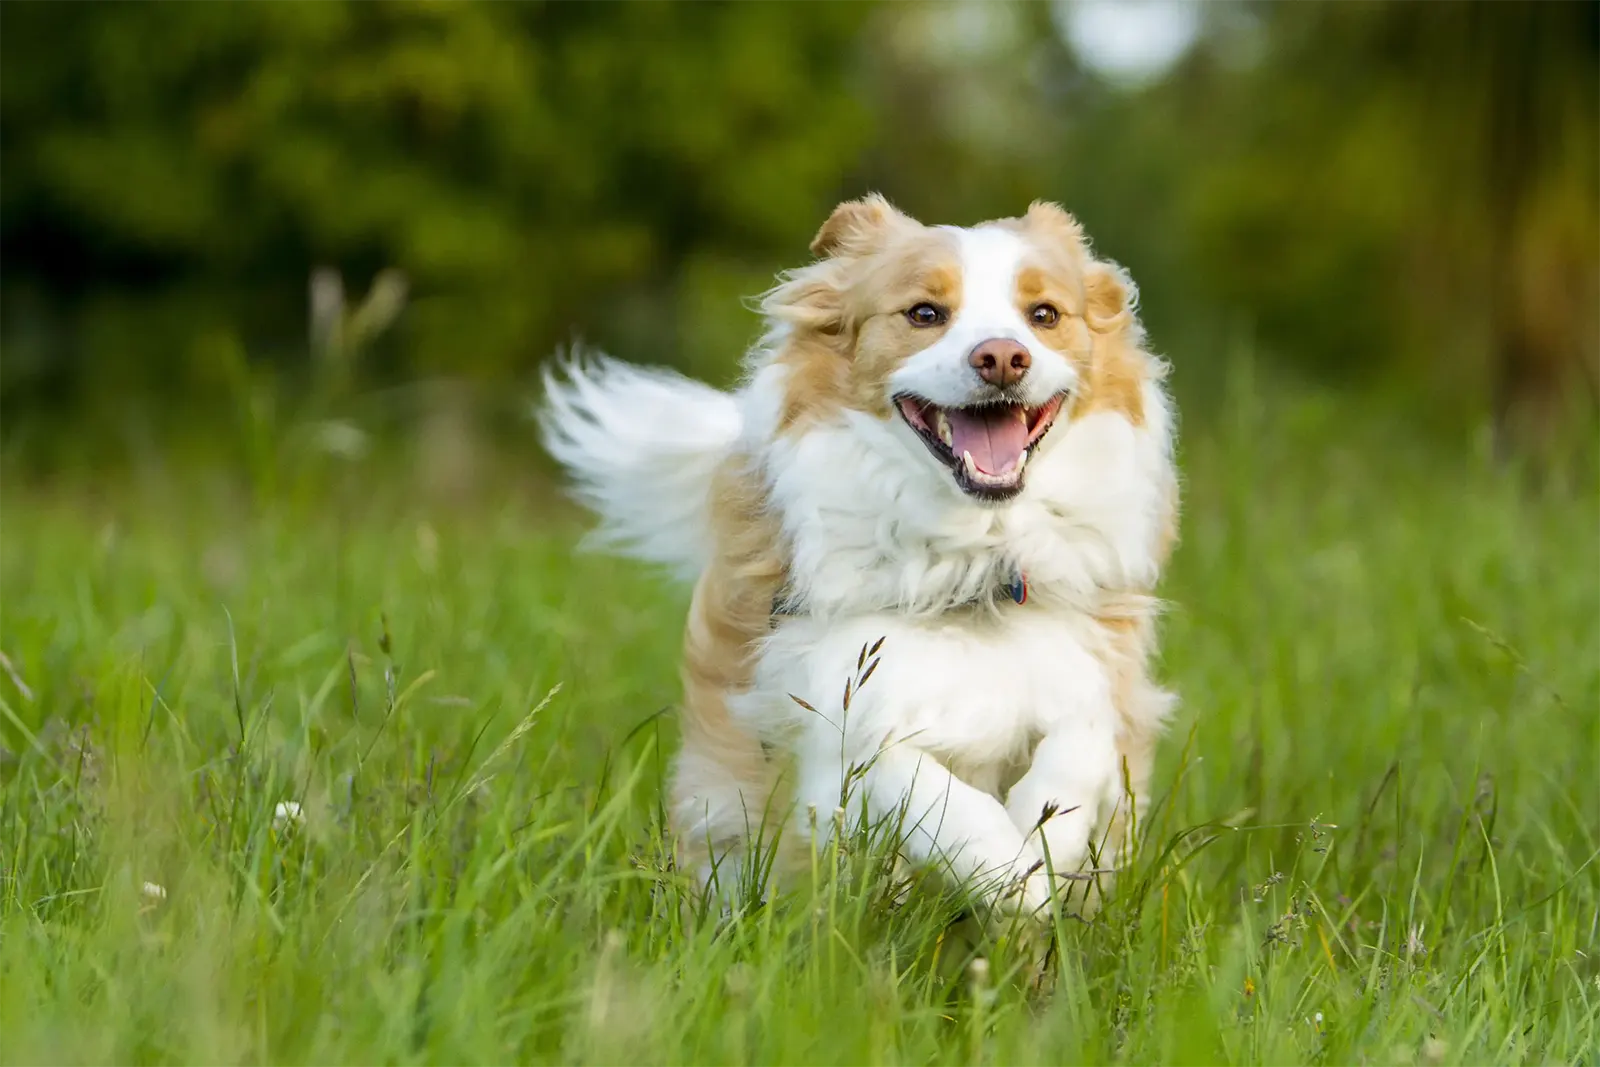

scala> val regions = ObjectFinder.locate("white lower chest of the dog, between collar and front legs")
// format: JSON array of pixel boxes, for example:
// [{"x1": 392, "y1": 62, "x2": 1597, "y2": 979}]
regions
[{"x1": 752, "y1": 605, "x2": 1115, "y2": 768}]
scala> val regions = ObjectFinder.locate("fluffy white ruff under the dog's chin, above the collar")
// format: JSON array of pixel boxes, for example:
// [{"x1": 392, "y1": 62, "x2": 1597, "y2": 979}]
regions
[{"x1": 747, "y1": 371, "x2": 1173, "y2": 617}]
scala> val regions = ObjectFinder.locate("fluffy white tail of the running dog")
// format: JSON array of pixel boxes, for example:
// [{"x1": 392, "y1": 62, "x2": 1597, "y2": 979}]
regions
[{"x1": 538, "y1": 355, "x2": 742, "y2": 577}]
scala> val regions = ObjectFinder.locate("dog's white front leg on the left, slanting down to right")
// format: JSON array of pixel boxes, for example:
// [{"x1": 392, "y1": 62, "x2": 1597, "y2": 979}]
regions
[{"x1": 800, "y1": 742, "x2": 1050, "y2": 910}]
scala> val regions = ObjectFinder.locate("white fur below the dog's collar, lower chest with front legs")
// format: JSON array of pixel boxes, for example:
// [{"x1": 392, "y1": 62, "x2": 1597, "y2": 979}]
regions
[{"x1": 730, "y1": 605, "x2": 1118, "y2": 905}]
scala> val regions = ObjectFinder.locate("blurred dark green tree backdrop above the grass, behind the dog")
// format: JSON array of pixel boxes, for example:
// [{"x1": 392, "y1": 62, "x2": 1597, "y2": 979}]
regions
[{"x1": 0, "y1": 0, "x2": 1600, "y2": 454}]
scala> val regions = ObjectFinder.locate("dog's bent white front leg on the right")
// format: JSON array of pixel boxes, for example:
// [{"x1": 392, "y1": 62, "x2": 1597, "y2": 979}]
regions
[{"x1": 1006, "y1": 718, "x2": 1117, "y2": 873}]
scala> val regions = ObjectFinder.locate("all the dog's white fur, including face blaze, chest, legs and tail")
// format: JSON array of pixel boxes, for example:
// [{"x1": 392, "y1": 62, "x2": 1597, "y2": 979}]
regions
[{"x1": 547, "y1": 220, "x2": 1176, "y2": 905}]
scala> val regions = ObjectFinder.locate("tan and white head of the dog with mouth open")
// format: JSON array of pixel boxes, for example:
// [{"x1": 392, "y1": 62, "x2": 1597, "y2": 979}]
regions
[{"x1": 763, "y1": 197, "x2": 1146, "y2": 502}]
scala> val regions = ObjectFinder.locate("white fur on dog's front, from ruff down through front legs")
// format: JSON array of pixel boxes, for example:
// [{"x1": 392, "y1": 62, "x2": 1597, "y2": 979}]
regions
[{"x1": 733, "y1": 369, "x2": 1171, "y2": 904}]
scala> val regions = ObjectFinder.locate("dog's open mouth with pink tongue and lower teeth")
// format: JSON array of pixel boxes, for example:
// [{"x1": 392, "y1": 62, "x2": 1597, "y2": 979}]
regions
[{"x1": 894, "y1": 394, "x2": 1066, "y2": 501}]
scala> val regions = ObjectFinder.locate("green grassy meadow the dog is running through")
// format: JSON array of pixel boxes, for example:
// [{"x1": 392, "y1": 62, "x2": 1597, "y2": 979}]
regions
[{"x1": 0, "y1": 385, "x2": 1600, "y2": 1067}]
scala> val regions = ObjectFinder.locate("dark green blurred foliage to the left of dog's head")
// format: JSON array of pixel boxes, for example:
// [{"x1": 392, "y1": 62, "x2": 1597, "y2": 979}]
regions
[{"x1": 0, "y1": 0, "x2": 867, "y2": 409}]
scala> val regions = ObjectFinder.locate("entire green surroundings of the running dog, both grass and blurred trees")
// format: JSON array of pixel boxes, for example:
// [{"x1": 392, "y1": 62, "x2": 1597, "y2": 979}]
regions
[{"x1": 0, "y1": 8, "x2": 1600, "y2": 1067}]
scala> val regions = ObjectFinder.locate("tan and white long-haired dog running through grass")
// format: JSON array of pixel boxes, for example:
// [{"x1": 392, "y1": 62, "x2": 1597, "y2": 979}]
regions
[{"x1": 541, "y1": 195, "x2": 1178, "y2": 912}]
